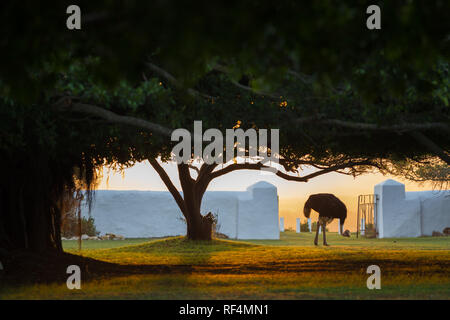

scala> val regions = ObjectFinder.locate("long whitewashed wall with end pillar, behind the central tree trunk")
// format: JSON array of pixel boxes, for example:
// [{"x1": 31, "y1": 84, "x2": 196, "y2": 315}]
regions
[{"x1": 82, "y1": 181, "x2": 280, "y2": 239}]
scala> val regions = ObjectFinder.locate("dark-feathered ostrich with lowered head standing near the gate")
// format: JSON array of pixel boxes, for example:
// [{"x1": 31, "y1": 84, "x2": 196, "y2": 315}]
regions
[{"x1": 303, "y1": 193, "x2": 347, "y2": 246}]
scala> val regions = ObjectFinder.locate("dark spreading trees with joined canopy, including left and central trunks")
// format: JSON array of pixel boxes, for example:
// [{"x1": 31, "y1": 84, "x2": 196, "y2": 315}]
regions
[{"x1": 0, "y1": 1, "x2": 450, "y2": 253}]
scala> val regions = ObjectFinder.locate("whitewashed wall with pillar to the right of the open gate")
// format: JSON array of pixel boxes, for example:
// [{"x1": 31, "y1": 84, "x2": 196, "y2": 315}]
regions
[{"x1": 374, "y1": 179, "x2": 450, "y2": 238}]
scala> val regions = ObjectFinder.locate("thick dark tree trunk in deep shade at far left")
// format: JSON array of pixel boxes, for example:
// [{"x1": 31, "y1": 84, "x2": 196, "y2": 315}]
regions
[{"x1": 0, "y1": 158, "x2": 64, "y2": 259}]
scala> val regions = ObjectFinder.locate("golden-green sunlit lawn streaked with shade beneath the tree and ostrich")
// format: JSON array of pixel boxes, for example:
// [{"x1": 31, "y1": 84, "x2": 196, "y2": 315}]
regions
[{"x1": 0, "y1": 231, "x2": 450, "y2": 299}]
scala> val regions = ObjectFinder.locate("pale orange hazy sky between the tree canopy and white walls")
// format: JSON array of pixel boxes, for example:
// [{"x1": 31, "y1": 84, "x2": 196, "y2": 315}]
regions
[{"x1": 99, "y1": 162, "x2": 430, "y2": 231}]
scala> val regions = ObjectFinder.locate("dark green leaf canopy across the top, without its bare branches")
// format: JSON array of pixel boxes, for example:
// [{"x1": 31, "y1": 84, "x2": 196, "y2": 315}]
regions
[{"x1": 0, "y1": 1, "x2": 450, "y2": 173}]
